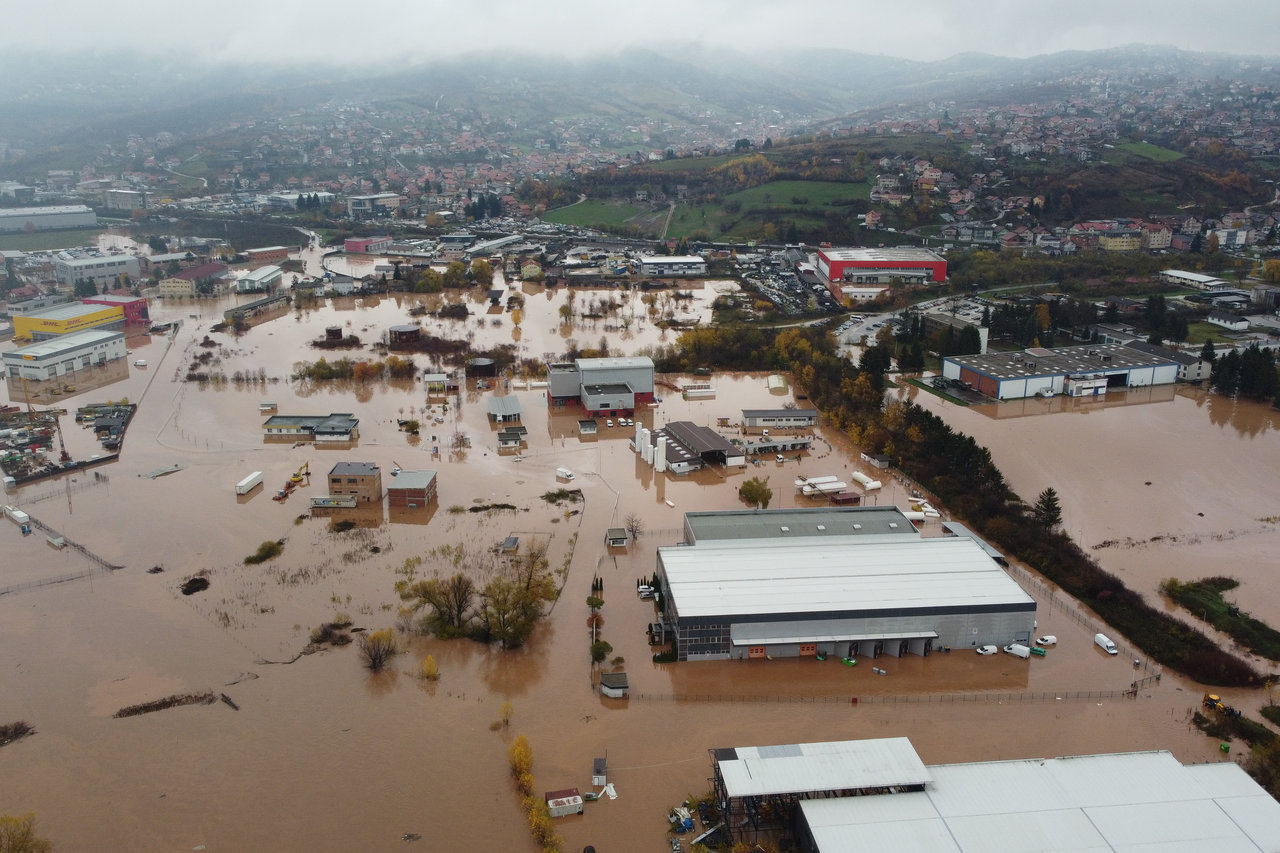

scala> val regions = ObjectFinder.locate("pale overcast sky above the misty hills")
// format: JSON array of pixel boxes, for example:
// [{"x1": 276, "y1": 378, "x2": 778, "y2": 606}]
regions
[{"x1": 10, "y1": 0, "x2": 1280, "y2": 63}]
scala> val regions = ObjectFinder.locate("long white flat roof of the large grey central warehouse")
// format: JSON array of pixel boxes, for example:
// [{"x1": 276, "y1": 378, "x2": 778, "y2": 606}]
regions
[{"x1": 658, "y1": 535, "x2": 1036, "y2": 621}]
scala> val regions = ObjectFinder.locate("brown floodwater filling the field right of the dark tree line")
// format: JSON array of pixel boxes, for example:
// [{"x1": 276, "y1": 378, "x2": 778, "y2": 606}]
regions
[{"x1": 905, "y1": 386, "x2": 1280, "y2": 669}]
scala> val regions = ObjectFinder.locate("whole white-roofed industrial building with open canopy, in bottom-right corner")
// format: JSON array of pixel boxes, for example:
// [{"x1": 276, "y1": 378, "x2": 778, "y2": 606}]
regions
[{"x1": 712, "y1": 738, "x2": 1280, "y2": 853}]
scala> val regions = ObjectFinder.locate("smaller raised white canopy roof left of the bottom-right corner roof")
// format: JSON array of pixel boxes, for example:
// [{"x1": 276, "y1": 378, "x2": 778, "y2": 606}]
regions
[{"x1": 716, "y1": 738, "x2": 933, "y2": 802}]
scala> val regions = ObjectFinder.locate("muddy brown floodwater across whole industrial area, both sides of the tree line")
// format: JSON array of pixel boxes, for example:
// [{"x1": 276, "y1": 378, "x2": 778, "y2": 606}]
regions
[{"x1": 0, "y1": 284, "x2": 1259, "y2": 853}]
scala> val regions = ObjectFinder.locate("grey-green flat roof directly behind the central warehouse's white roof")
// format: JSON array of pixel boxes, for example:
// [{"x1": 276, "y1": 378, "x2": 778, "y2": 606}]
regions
[{"x1": 685, "y1": 506, "x2": 920, "y2": 542}]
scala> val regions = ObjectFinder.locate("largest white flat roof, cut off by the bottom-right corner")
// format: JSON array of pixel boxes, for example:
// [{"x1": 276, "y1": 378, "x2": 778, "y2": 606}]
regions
[{"x1": 800, "y1": 752, "x2": 1280, "y2": 853}]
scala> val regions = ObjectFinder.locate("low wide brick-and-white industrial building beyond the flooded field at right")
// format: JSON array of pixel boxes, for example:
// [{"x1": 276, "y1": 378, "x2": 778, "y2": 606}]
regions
[{"x1": 942, "y1": 343, "x2": 1180, "y2": 400}]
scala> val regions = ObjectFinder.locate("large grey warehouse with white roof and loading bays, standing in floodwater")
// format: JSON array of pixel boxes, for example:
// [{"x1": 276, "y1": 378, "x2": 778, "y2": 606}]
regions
[{"x1": 657, "y1": 506, "x2": 1036, "y2": 661}]
